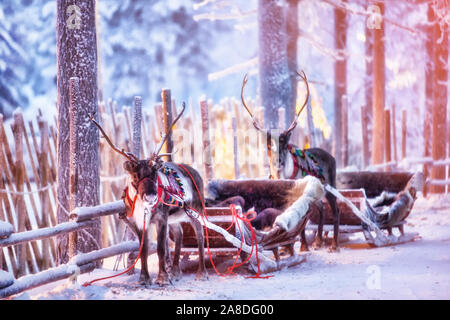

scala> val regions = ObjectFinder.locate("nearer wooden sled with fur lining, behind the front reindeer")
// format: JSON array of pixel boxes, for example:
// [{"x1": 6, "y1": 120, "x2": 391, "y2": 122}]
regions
[{"x1": 178, "y1": 177, "x2": 324, "y2": 273}]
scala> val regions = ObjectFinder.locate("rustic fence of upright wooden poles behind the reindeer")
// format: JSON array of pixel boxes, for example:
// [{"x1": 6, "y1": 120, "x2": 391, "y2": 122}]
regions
[{"x1": 0, "y1": 91, "x2": 450, "y2": 277}]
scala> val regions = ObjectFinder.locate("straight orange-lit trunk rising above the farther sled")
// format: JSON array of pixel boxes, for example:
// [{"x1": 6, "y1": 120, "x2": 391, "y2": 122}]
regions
[{"x1": 372, "y1": 2, "x2": 385, "y2": 164}]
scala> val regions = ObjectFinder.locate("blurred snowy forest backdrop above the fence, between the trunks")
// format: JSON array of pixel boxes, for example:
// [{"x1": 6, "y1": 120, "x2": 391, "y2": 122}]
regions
[{"x1": 0, "y1": 0, "x2": 449, "y2": 168}]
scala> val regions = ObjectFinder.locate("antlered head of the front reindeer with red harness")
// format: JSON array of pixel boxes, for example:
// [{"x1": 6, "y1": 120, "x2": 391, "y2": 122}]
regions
[{"x1": 91, "y1": 102, "x2": 186, "y2": 204}]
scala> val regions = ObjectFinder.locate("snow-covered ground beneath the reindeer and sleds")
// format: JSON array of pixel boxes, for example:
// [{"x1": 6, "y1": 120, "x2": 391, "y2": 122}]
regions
[{"x1": 7, "y1": 192, "x2": 450, "y2": 300}]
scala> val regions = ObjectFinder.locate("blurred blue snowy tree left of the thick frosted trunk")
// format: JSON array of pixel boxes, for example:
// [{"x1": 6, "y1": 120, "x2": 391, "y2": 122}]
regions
[{"x1": 0, "y1": 0, "x2": 56, "y2": 115}]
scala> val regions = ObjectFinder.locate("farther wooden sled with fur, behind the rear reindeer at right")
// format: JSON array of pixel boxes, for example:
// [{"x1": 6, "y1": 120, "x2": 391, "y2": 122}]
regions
[{"x1": 307, "y1": 172, "x2": 423, "y2": 247}]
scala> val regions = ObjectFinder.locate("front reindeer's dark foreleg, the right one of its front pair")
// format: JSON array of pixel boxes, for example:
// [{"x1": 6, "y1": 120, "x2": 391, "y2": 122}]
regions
[{"x1": 155, "y1": 209, "x2": 170, "y2": 286}]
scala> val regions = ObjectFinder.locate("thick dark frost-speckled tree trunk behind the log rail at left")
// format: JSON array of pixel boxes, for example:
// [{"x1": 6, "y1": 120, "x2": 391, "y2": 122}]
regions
[{"x1": 56, "y1": 0, "x2": 101, "y2": 263}]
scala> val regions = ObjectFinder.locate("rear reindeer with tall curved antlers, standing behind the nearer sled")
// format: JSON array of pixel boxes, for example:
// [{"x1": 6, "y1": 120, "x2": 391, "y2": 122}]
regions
[{"x1": 241, "y1": 71, "x2": 339, "y2": 251}]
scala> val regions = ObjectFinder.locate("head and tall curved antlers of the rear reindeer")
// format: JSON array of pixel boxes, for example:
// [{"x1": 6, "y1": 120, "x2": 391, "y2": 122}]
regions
[{"x1": 241, "y1": 71, "x2": 309, "y2": 179}]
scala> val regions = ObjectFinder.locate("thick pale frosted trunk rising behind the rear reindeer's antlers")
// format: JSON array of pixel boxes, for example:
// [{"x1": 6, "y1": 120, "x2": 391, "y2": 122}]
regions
[{"x1": 258, "y1": 0, "x2": 292, "y2": 129}]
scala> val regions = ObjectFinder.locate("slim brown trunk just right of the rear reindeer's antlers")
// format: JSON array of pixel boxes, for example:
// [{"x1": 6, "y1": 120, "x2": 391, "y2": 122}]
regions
[{"x1": 333, "y1": 0, "x2": 347, "y2": 167}]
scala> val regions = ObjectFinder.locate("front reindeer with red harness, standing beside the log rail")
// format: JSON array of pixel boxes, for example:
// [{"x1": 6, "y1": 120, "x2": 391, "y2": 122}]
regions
[{"x1": 91, "y1": 103, "x2": 207, "y2": 286}]
